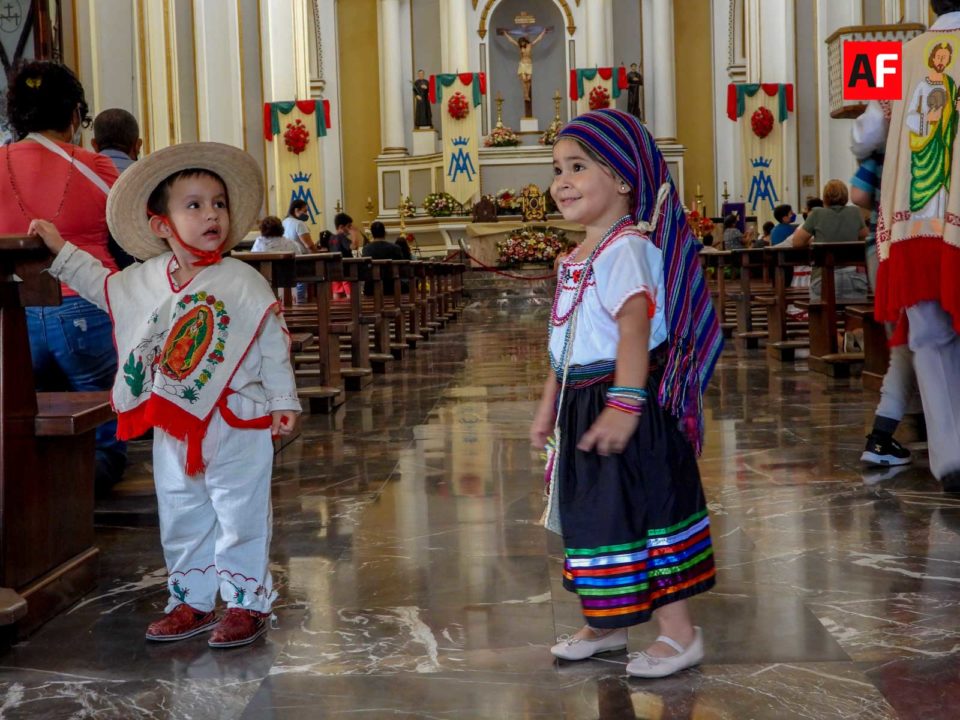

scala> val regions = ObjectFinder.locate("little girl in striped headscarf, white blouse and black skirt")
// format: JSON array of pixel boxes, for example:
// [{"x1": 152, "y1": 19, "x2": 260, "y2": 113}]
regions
[{"x1": 530, "y1": 110, "x2": 722, "y2": 677}]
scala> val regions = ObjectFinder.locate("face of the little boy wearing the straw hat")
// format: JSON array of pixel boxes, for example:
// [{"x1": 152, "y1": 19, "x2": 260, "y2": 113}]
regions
[{"x1": 155, "y1": 175, "x2": 230, "y2": 266}]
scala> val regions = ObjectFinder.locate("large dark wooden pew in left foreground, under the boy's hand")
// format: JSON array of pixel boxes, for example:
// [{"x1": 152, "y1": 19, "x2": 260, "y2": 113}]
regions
[{"x1": 0, "y1": 236, "x2": 113, "y2": 637}]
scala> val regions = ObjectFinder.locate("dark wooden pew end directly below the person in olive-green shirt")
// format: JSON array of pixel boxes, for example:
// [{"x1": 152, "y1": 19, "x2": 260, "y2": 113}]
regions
[{"x1": 797, "y1": 242, "x2": 866, "y2": 377}]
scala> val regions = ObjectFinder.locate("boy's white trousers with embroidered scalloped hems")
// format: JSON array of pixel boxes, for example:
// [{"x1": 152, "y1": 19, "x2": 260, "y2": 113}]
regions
[{"x1": 153, "y1": 395, "x2": 277, "y2": 612}]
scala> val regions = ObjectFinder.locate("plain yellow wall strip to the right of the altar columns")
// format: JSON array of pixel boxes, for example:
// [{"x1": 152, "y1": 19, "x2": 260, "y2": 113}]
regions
[{"x1": 673, "y1": 0, "x2": 720, "y2": 215}]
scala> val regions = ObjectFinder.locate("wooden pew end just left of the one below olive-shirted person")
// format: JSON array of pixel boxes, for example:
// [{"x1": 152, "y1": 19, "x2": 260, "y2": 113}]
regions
[{"x1": 761, "y1": 246, "x2": 810, "y2": 362}]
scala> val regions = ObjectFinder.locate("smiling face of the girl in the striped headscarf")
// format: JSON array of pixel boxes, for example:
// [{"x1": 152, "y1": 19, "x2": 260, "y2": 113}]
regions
[{"x1": 550, "y1": 138, "x2": 630, "y2": 230}]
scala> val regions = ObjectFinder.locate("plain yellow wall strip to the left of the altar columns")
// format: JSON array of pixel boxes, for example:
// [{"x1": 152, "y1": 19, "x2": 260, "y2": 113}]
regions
[{"x1": 340, "y1": 0, "x2": 380, "y2": 222}]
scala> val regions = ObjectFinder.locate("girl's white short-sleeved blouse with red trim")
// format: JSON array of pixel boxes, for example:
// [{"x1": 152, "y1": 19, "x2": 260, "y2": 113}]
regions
[{"x1": 550, "y1": 233, "x2": 667, "y2": 370}]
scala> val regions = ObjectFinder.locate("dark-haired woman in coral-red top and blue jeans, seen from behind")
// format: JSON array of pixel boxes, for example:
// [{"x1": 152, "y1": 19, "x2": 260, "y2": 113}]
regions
[{"x1": 0, "y1": 61, "x2": 126, "y2": 489}]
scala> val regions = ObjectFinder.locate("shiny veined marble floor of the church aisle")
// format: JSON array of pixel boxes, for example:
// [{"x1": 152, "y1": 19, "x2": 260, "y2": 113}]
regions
[{"x1": 0, "y1": 303, "x2": 960, "y2": 720}]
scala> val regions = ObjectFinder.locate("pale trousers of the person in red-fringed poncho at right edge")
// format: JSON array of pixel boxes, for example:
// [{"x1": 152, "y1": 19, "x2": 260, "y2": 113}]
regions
[{"x1": 907, "y1": 302, "x2": 960, "y2": 480}]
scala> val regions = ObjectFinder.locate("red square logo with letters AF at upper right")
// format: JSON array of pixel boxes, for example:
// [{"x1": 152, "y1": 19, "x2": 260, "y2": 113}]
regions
[{"x1": 843, "y1": 40, "x2": 903, "y2": 102}]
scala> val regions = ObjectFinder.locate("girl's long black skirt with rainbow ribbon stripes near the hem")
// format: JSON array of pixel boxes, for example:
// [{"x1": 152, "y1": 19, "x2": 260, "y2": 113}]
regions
[{"x1": 557, "y1": 353, "x2": 716, "y2": 628}]
